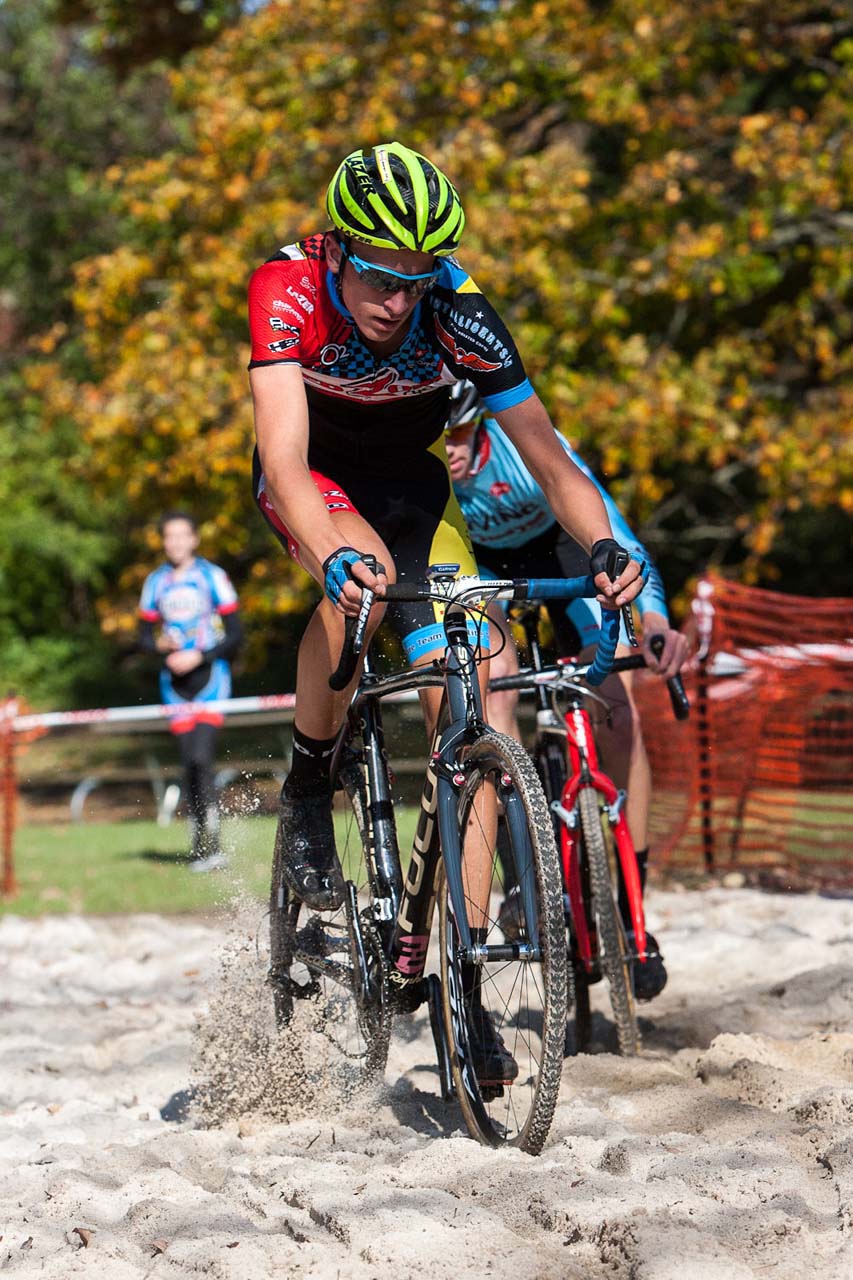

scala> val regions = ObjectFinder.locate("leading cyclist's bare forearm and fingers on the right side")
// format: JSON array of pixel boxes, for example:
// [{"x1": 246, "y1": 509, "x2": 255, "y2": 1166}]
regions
[{"x1": 494, "y1": 396, "x2": 643, "y2": 608}]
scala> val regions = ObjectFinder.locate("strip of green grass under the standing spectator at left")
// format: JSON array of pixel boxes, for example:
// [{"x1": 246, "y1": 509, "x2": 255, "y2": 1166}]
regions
[{"x1": 0, "y1": 809, "x2": 416, "y2": 916}]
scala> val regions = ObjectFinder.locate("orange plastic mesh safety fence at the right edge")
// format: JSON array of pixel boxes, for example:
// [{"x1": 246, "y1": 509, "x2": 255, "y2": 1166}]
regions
[{"x1": 638, "y1": 579, "x2": 853, "y2": 887}]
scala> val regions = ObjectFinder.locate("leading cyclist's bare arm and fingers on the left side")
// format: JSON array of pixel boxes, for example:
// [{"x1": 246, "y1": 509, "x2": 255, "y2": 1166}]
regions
[{"x1": 248, "y1": 364, "x2": 384, "y2": 614}]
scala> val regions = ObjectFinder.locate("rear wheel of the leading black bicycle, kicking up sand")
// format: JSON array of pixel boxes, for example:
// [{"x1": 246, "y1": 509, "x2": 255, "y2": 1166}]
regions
[{"x1": 270, "y1": 762, "x2": 391, "y2": 1092}]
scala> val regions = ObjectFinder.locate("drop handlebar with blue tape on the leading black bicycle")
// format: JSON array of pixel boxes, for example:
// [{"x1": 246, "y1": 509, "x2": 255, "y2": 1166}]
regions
[{"x1": 329, "y1": 570, "x2": 621, "y2": 692}]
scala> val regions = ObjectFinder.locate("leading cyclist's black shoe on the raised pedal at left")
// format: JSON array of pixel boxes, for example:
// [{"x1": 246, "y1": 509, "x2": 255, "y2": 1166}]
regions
[{"x1": 278, "y1": 782, "x2": 345, "y2": 911}]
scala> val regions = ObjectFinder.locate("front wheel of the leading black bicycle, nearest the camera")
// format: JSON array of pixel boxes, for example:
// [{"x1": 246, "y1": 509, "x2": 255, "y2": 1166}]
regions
[{"x1": 439, "y1": 732, "x2": 570, "y2": 1155}]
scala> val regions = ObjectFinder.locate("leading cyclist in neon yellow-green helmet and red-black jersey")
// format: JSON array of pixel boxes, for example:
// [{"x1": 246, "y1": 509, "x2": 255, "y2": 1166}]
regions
[{"x1": 248, "y1": 142, "x2": 642, "y2": 1078}]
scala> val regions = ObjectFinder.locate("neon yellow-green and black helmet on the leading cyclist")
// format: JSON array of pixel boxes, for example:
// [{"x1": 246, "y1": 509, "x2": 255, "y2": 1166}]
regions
[{"x1": 325, "y1": 142, "x2": 465, "y2": 257}]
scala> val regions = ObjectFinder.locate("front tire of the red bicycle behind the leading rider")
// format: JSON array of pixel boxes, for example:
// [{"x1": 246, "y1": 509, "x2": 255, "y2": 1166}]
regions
[{"x1": 578, "y1": 786, "x2": 640, "y2": 1057}]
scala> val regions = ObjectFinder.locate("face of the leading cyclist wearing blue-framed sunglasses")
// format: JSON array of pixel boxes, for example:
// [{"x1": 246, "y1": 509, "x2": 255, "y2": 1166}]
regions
[{"x1": 325, "y1": 236, "x2": 435, "y2": 349}]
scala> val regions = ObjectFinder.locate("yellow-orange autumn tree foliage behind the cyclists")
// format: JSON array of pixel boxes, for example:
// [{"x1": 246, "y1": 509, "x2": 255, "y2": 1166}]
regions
[{"x1": 28, "y1": 0, "x2": 853, "y2": 675}]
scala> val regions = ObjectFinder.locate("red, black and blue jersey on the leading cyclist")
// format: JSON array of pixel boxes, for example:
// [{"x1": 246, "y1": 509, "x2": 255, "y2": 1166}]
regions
[{"x1": 248, "y1": 232, "x2": 533, "y2": 474}]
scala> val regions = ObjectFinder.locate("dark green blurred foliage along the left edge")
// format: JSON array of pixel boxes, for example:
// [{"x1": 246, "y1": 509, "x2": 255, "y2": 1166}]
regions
[{"x1": 0, "y1": 0, "x2": 183, "y2": 701}]
